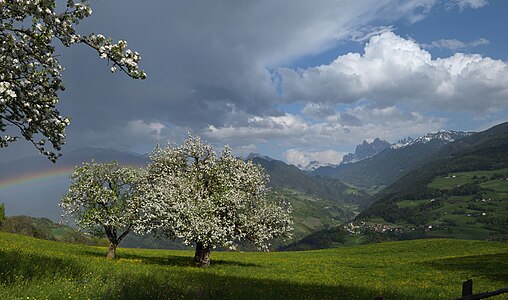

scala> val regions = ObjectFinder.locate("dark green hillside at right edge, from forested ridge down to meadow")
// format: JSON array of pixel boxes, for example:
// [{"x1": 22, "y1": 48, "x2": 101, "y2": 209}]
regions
[{"x1": 356, "y1": 123, "x2": 508, "y2": 239}]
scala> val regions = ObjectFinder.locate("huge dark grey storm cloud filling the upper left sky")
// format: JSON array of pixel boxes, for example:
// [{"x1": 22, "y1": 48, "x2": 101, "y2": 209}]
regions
[{"x1": 49, "y1": 0, "x2": 444, "y2": 148}]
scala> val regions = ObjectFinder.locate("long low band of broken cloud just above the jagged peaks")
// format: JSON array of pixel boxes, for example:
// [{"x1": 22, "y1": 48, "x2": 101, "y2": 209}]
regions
[{"x1": 202, "y1": 104, "x2": 445, "y2": 153}]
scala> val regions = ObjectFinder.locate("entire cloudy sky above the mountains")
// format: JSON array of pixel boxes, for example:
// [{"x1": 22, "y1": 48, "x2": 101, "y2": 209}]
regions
[{"x1": 0, "y1": 0, "x2": 508, "y2": 165}]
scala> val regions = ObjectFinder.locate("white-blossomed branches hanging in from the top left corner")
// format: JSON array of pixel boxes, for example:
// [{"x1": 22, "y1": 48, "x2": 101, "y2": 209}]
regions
[{"x1": 0, "y1": 0, "x2": 146, "y2": 162}]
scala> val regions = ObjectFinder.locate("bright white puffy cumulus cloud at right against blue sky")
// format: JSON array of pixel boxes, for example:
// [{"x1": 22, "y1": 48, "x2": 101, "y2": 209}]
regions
[{"x1": 277, "y1": 32, "x2": 508, "y2": 114}]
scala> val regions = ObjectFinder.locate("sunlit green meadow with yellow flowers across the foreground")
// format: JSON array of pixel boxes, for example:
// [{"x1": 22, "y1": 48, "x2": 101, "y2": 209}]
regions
[{"x1": 0, "y1": 233, "x2": 508, "y2": 299}]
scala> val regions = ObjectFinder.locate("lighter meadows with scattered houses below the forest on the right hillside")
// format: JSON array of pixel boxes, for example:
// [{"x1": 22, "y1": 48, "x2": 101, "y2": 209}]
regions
[{"x1": 355, "y1": 169, "x2": 508, "y2": 240}]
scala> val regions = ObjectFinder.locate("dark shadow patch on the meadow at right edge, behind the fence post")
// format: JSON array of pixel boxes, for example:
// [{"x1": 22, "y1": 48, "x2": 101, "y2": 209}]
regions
[{"x1": 422, "y1": 252, "x2": 508, "y2": 286}]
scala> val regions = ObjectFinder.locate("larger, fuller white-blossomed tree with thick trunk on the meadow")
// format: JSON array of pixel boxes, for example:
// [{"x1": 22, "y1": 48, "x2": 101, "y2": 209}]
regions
[{"x1": 138, "y1": 136, "x2": 292, "y2": 266}]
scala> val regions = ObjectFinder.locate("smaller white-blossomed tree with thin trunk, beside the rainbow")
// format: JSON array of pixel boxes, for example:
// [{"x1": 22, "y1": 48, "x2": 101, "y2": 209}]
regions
[{"x1": 60, "y1": 161, "x2": 145, "y2": 258}]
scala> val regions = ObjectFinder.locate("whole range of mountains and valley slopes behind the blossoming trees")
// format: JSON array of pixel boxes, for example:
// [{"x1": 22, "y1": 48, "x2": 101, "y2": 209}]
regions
[{"x1": 0, "y1": 123, "x2": 508, "y2": 249}]
